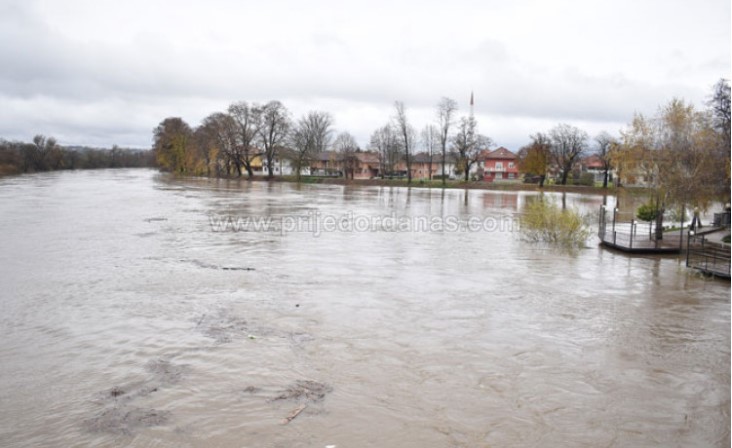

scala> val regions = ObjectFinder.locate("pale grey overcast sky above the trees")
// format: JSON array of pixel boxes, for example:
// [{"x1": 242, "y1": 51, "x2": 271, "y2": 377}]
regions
[{"x1": 0, "y1": 0, "x2": 732, "y2": 151}]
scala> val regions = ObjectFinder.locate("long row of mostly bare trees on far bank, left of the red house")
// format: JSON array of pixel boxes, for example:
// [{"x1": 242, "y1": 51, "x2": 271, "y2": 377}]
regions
[{"x1": 153, "y1": 98, "x2": 493, "y2": 186}]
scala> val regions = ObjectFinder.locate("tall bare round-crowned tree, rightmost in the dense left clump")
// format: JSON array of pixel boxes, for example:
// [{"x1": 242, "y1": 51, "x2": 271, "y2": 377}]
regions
[{"x1": 290, "y1": 111, "x2": 333, "y2": 182}]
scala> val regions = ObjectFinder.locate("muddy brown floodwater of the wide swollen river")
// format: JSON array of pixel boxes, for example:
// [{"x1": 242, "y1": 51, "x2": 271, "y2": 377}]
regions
[{"x1": 0, "y1": 170, "x2": 730, "y2": 447}]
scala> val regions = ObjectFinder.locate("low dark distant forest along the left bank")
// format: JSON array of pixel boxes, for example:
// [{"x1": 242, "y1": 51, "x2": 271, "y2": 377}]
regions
[{"x1": 0, "y1": 135, "x2": 156, "y2": 176}]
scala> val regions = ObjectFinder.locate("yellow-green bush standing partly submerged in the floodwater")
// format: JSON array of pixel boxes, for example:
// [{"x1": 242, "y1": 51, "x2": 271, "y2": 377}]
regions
[{"x1": 519, "y1": 198, "x2": 590, "y2": 248}]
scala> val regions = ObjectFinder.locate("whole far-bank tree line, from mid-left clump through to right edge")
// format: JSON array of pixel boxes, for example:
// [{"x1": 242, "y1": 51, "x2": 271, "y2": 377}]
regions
[{"x1": 153, "y1": 80, "x2": 730, "y2": 203}]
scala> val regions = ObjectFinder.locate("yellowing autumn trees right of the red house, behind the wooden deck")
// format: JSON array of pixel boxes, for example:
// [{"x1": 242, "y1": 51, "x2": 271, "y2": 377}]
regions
[{"x1": 518, "y1": 79, "x2": 730, "y2": 203}]
